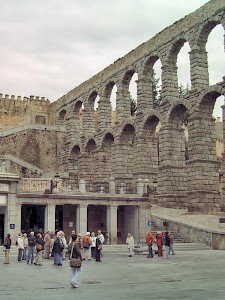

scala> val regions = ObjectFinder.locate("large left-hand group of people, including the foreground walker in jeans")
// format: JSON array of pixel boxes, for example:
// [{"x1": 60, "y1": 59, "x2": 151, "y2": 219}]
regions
[{"x1": 4, "y1": 230, "x2": 105, "y2": 288}]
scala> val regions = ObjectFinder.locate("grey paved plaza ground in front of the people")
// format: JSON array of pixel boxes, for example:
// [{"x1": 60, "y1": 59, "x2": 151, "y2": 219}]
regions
[{"x1": 0, "y1": 250, "x2": 225, "y2": 300}]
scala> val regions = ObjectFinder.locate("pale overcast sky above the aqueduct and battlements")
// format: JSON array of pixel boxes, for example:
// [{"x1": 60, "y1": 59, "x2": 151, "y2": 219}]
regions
[{"x1": 0, "y1": 0, "x2": 225, "y2": 116}]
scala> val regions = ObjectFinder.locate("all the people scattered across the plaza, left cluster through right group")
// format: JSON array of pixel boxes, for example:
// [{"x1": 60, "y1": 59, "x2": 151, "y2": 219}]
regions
[{"x1": 4, "y1": 230, "x2": 175, "y2": 288}]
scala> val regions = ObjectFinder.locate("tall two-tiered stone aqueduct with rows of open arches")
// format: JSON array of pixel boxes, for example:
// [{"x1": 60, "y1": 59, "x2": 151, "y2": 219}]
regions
[{"x1": 48, "y1": 0, "x2": 225, "y2": 212}]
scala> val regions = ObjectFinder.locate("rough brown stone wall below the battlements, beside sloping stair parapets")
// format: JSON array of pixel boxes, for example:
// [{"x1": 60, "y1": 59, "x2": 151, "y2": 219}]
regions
[{"x1": 0, "y1": 127, "x2": 65, "y2": 177}]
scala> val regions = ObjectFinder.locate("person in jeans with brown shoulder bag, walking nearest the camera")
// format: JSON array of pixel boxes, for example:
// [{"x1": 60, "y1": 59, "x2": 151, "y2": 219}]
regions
[{"x1": 68, "y1": 234, "x2": 82, "y2": 288}]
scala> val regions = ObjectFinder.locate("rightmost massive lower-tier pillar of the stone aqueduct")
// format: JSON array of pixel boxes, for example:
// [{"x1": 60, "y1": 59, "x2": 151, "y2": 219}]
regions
[{"x1": 187, "y1": 116, "x2": 220, "y2": 213}]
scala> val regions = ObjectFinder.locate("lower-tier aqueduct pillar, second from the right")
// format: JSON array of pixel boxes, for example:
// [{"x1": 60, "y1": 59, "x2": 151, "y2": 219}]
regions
[{"x1": 157, "y1": 124, "x2": 186, "y2": 208}]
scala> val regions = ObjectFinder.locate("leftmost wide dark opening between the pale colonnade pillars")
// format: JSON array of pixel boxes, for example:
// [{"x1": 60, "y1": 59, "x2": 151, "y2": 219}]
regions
[{"x1": 21, "y1": 204, "x2": 45, "y2": 233}]
